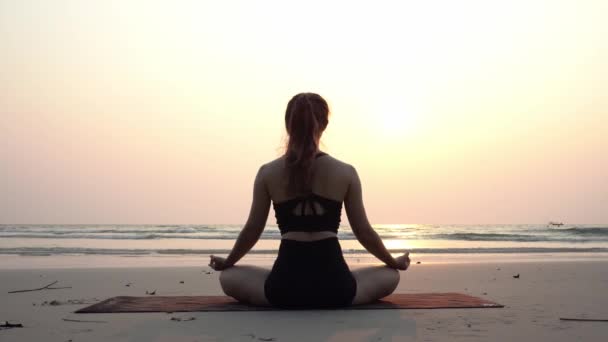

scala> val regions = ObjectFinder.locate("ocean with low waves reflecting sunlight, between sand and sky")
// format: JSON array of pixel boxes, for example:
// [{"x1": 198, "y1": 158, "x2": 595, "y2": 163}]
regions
[{"x1": 0, "y1": 224, "x2": 608, "y2": 256}]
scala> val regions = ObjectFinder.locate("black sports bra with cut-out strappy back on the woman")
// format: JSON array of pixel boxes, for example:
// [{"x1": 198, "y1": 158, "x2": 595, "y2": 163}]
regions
[{"x1": 272, "y1": 152, "x2": 342, "y2": 235}]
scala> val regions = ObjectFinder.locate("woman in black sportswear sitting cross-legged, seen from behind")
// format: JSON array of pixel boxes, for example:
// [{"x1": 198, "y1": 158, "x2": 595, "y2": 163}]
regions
[{"x1": 209, "y1": 93, "x2": 410, "y2": 308}]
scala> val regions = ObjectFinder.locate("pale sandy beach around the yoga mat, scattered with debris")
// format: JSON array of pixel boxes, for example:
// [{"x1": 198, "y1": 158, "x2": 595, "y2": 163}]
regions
[{"x1": 0, "y1": 255, "x2": 608, "y2": 342}]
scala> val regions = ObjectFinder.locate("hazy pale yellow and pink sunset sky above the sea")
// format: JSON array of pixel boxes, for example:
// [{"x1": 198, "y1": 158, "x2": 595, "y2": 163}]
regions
[{"x1": 0, "y1": 0, "x2": 608, "y2": 224}]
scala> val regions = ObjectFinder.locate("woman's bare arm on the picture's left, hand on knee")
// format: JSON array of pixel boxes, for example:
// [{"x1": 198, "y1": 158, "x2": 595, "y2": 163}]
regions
[{"x1": 210, "y1": 165, "x2": 270, "y2": 270}]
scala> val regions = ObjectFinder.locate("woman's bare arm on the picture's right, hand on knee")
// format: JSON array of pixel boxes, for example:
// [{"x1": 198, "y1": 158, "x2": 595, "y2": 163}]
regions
[{"x1": 344, "y1": 166, "x2": 409, "y2": 270}]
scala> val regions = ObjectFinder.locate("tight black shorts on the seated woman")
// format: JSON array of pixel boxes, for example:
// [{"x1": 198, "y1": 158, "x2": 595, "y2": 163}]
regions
[{"x1": 264, "y1": 237, "x2": 357, "y2": 309}]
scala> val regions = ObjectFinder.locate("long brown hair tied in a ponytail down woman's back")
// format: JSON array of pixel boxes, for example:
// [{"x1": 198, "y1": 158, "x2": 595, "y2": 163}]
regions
[{"x1": 285, "y1": 93, "x2": 329, "y2": 194}]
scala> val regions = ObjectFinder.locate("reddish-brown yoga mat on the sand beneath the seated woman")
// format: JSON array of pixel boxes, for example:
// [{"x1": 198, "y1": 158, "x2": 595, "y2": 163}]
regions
[{"x1": 76, "y1": 293, "x2": 503, "y2": 313}]
